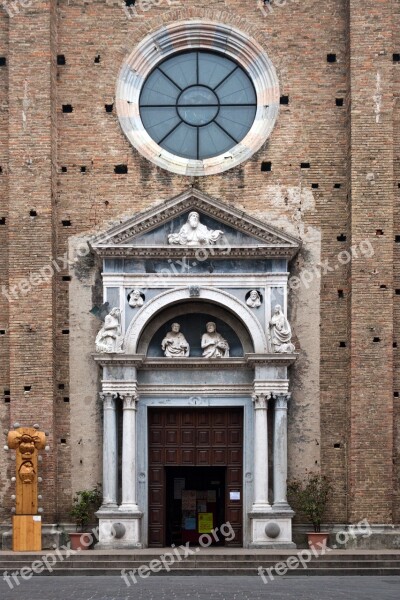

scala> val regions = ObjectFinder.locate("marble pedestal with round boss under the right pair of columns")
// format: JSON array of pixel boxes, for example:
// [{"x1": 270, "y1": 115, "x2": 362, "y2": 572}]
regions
[{"x1": 249, "y1": 506, "x2": 296, "y2": 549}]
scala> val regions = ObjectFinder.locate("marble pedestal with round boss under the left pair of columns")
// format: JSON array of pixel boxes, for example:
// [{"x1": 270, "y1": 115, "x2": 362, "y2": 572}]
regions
[{"x1": 96, "y1": 508, "x2": 143, "y2": 550}]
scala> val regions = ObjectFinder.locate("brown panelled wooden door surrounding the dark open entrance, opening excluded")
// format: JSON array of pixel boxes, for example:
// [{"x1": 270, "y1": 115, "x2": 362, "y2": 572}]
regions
[{"x1": 148, "y1": 408, "x2": 243, "y2": 547}]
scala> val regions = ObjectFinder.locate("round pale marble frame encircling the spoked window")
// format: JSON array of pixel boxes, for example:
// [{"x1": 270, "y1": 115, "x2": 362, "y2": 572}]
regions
[{"x1": 116, "y1": 20, "x2": 280, "y2": 177}]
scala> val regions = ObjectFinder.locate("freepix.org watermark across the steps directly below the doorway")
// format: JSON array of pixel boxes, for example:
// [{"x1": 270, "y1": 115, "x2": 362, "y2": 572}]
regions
[{"x1": 121, "y1": 521, "x2": 235, "y2": 587}]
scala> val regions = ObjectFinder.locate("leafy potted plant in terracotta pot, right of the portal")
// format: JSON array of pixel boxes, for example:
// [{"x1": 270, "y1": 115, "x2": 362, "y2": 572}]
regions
[{"x1": 288, "y1": 472, "x2": 333, "y2": 548}]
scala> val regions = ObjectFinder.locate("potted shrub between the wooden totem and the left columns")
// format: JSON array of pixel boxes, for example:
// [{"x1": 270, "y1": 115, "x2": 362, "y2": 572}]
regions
[{"x1": 69, "y1": 484, "x2": 102, "y2": 550}]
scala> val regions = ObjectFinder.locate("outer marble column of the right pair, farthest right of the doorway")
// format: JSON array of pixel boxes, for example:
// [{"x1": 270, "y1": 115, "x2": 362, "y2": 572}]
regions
[{"x1": 273, "y1": 394, "x2": 290, "y2": 509}]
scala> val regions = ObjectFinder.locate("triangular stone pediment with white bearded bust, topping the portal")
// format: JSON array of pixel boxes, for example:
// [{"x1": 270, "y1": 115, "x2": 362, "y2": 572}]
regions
[{"x1": 91, "y1": 188, "x2": 300, "y2": 258}]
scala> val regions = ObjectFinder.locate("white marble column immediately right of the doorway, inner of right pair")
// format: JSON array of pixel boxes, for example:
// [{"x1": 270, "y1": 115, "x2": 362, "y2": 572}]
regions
[{"x1": 253, "y1": 393, "x2": 271, "y2": 512}]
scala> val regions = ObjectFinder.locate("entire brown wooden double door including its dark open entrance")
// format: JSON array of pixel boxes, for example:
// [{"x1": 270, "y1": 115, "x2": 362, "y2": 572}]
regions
[{"x1": 148, "y1": 407, "x2": 243, "y2": 547}]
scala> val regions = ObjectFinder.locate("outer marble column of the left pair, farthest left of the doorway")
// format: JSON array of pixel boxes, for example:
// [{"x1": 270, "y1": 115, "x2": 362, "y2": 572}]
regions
[{"x1": 100, "y1": 393, "x2": 118, "y2": 509}]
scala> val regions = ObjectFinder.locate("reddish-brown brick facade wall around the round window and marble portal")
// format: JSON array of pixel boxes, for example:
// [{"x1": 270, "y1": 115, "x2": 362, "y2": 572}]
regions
[{"x1": 0, "y1": 0, "x2": 400, "y2": 524}]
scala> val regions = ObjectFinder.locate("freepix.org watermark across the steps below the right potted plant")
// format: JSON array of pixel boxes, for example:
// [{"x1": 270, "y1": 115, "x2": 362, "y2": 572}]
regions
[{"x1": 257, "y1": 519, "x2": 372, "y2": 583}]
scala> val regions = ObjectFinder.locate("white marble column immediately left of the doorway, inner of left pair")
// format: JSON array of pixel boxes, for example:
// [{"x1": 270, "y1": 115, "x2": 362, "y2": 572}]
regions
[{"x1": 120, "y1": 393, "x2": 139, "y2": 512}]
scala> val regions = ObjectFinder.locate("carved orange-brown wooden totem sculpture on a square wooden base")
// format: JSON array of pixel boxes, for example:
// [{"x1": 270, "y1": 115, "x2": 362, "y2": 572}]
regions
[{"x1": 7, "y1": 427, "x2": 46, "y2": 551}]
